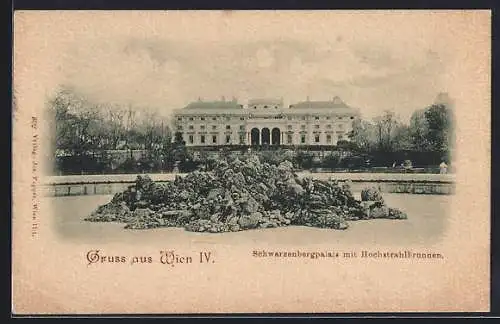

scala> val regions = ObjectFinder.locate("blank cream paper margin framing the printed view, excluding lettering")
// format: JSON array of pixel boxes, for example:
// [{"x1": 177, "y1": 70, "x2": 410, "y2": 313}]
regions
[{"x1": 12, "y1": 11, "x2": 491, "y2": 314}]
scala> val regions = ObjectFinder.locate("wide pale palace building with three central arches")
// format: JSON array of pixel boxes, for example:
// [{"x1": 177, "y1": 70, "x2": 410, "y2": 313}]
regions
[{"x1": 173, "y1": 97, "x2": 359, "y2": 146}]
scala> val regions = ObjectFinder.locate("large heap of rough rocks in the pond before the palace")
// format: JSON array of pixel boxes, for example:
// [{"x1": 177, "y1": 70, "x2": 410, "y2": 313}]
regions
[{"x1": 86, "y1": 156, "x2": 407, "y2": 233}]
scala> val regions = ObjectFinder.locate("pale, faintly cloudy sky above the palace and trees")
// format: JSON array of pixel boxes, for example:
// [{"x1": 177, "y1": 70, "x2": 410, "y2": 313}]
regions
[{"x1": 17, "y1": 11, "x2": 476, "y2": 121}]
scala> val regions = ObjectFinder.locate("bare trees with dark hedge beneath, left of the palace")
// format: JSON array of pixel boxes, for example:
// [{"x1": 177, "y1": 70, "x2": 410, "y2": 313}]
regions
[{"x1": 47, "y1": 87, "x2": 185, "y2": 173}]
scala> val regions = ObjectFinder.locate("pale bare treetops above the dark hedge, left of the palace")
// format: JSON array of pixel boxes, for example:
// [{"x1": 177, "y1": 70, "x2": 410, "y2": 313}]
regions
[{"x1": 48, "y1": 88, "x2": 170, "y2": 154}]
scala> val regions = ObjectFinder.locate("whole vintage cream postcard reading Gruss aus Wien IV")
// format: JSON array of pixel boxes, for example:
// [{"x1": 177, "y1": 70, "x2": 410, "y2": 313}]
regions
[{"x1": 12, "y1": 10, "x2": 491, "y2": 315}]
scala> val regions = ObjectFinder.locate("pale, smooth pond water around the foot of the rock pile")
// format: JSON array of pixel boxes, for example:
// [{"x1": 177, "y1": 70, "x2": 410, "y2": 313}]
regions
[{"x1": 48, "y1": 193, "x2": 452, "y2": 245}]
